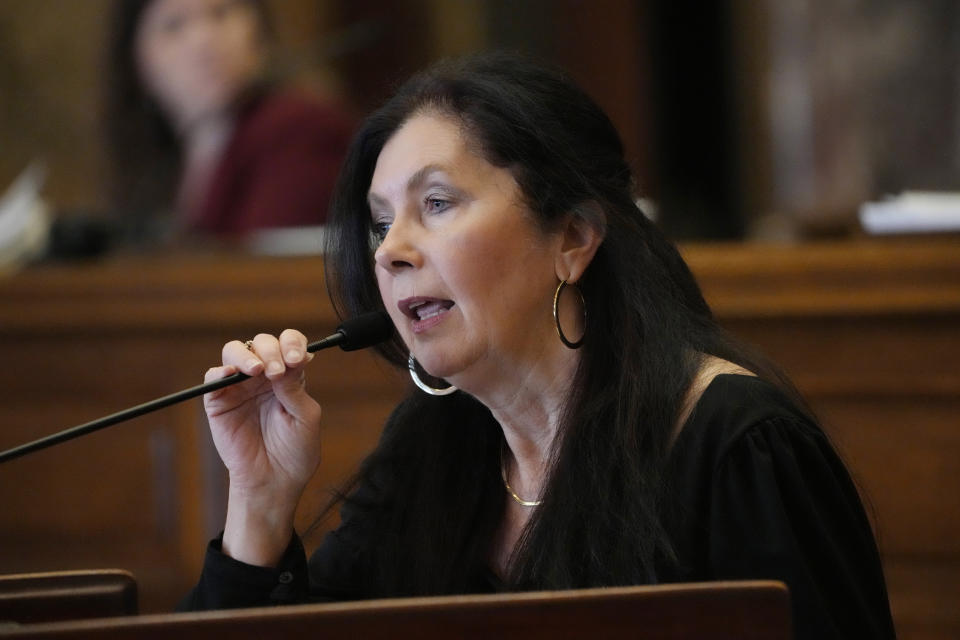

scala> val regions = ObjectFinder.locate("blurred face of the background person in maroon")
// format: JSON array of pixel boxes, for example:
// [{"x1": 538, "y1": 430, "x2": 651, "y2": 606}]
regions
[{"x1": 135, "y1": 0, "x2": 266, "y2": 129}]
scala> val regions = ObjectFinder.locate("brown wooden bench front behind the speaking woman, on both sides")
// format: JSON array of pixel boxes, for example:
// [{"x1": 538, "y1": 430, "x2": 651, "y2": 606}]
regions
[{"x1": 0, "y1": 238, "x2": 960, "y2": 638}]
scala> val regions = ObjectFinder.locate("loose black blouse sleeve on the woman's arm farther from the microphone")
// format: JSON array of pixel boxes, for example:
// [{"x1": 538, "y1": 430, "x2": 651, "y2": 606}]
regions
[{"x1": 708, "y1": 418, "x2": 895, "y2": 640}]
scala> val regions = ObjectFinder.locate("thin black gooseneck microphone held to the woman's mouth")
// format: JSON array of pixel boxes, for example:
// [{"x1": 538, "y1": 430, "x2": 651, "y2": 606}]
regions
[{"x1": 0, "y1": 311, "x2": 393, "y2": 463}]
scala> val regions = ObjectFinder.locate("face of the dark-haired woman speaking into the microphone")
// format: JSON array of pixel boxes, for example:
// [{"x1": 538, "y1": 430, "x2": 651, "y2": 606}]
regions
[{"x1": 368, "y1": 115, "x2": 562, "y2": 389}]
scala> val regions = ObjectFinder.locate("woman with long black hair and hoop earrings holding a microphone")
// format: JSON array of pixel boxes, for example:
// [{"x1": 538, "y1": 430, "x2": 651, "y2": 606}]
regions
[{"x1": 178, "y1": 55, "x2": 893, "y2": 638}]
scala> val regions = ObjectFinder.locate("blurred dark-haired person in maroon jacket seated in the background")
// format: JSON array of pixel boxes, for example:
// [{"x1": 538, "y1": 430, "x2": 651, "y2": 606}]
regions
[{"x1": 104, "y1": 0, "x2": 352, "y2": 242}]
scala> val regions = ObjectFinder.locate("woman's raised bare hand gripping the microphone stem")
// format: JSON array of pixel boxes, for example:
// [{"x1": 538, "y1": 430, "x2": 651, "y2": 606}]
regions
[{"x1": 203, "y1": 329, "x2": 320, "y2": 565}]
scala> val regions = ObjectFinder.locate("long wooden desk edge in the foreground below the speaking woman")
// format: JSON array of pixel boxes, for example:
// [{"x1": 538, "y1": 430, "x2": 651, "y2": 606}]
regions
[{"x1": 0, "y1": 581, "x2": 793, "y2": 640}]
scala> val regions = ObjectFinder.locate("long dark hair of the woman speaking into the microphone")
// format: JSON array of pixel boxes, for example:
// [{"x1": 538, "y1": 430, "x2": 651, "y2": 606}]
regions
[{"x1": 318, "y1": 53, "x2": 789, "y2": 596}]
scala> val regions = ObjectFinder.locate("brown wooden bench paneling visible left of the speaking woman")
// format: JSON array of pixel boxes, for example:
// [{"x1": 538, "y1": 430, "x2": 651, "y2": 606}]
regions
[{"x1": 0, "y1": 251, "x2": 403, "y2": 611}]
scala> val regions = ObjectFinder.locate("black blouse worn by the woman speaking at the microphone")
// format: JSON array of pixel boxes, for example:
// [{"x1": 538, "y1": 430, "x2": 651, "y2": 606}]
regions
[{"x1": 180, "y1": 375, "x2": 895, "y2": 639}]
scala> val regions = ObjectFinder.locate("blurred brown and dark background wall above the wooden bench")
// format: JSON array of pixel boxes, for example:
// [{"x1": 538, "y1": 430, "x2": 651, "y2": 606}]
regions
[{"x1": 0, "y1": 0, "x2": 960, "y2": 239}]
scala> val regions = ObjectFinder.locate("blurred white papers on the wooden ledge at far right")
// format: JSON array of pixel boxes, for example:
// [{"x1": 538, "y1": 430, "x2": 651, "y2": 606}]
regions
[{"x1": 860, "y1": 191, "x2": 960, "y2": 234}]
